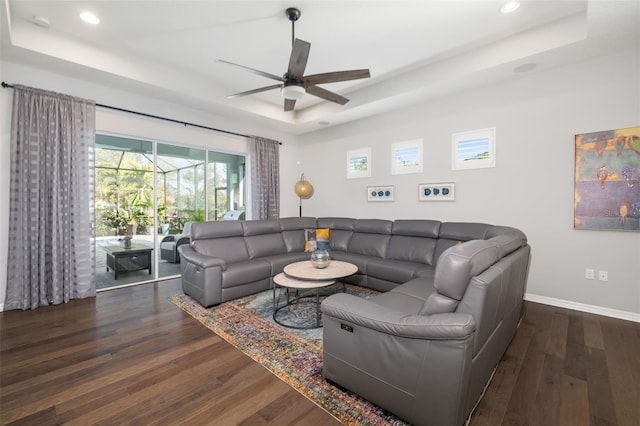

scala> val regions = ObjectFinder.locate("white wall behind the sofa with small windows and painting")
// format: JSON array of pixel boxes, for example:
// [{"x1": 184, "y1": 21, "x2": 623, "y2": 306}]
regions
[{"x1": 292, "y1": 46, "x2": 640, "y2": 321}]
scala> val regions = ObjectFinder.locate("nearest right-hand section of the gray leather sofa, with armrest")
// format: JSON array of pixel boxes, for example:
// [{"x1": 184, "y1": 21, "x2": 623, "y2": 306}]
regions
[{"x1": 322, "y1": 228, "x2": 530, "y2": 425}]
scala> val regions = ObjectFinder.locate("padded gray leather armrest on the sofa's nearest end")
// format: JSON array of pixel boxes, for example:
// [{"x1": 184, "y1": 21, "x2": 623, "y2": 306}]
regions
[{"x1": 322, "y1": 293, "x2": 475, "y2": 340}]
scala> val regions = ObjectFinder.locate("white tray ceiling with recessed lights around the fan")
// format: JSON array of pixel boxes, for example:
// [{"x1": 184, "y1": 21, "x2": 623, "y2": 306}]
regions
[{"x1": 0, "y1": 0, "x2": 640, "y2": 133}]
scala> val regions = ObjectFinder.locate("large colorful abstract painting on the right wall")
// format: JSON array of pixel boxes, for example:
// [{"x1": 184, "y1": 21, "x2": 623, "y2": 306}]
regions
[{"x1": 573, "y1": 126, "x2": 640, "y2": 231}]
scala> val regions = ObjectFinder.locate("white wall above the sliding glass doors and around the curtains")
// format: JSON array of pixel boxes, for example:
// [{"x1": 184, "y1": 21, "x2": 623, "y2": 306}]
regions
[{"x1": 0, "y1": 62, "x2": 297, "y2": 310}]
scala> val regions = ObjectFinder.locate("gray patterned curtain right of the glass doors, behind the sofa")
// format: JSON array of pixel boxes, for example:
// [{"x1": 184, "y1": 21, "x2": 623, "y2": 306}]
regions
[{"x1": 249, "y1": 136, "x2": 280, "y2": 219}]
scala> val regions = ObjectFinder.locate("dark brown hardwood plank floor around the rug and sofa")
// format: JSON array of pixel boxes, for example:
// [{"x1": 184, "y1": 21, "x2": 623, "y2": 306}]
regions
[{"x1": 0, "y1": 280, "x2": 640, "y2": 426}]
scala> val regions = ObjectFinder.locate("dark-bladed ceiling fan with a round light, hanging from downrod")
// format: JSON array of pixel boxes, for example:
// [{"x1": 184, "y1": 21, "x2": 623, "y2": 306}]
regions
[{"x1": 219, "y1": 7, "x2": 371, "y2": 111}]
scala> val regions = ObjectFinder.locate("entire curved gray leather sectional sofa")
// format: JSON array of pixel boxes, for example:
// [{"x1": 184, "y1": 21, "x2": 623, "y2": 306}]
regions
[{"x1": 178, "y1": 217, "x2": 530, "y2": 425}]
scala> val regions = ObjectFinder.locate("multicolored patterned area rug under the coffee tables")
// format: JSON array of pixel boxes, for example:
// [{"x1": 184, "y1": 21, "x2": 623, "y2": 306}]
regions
[{"x1": 169, "y1": 285, "x2": 406, "y2": 425}]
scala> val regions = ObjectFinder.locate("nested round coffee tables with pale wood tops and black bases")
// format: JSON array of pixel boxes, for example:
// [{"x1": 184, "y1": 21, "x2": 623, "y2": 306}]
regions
[{"x1": 273, "y1": 260, "x2": 358, "y2": 330}]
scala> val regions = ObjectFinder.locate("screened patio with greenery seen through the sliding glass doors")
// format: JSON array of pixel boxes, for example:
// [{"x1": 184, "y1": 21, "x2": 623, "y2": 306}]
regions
[{"x1": 95, "y1": 134, "x2": 246, "y2": 288}]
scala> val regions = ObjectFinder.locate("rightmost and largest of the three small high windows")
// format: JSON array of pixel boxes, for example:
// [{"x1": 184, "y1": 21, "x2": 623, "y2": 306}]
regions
[{"x1": 451, "y1": 127, "x2": 496, "y2": 170}]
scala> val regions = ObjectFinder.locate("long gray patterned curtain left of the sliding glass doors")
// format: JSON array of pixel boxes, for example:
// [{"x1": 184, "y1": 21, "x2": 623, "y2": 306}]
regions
[{"x1": 4, "y1": 86, "x2": 96, "y2": 310}]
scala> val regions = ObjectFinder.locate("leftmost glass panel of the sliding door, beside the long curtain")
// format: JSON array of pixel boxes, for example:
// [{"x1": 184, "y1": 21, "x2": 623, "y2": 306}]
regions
[{"x1": 95, "y1": 135, "x2": 155, "y2": 289}]
